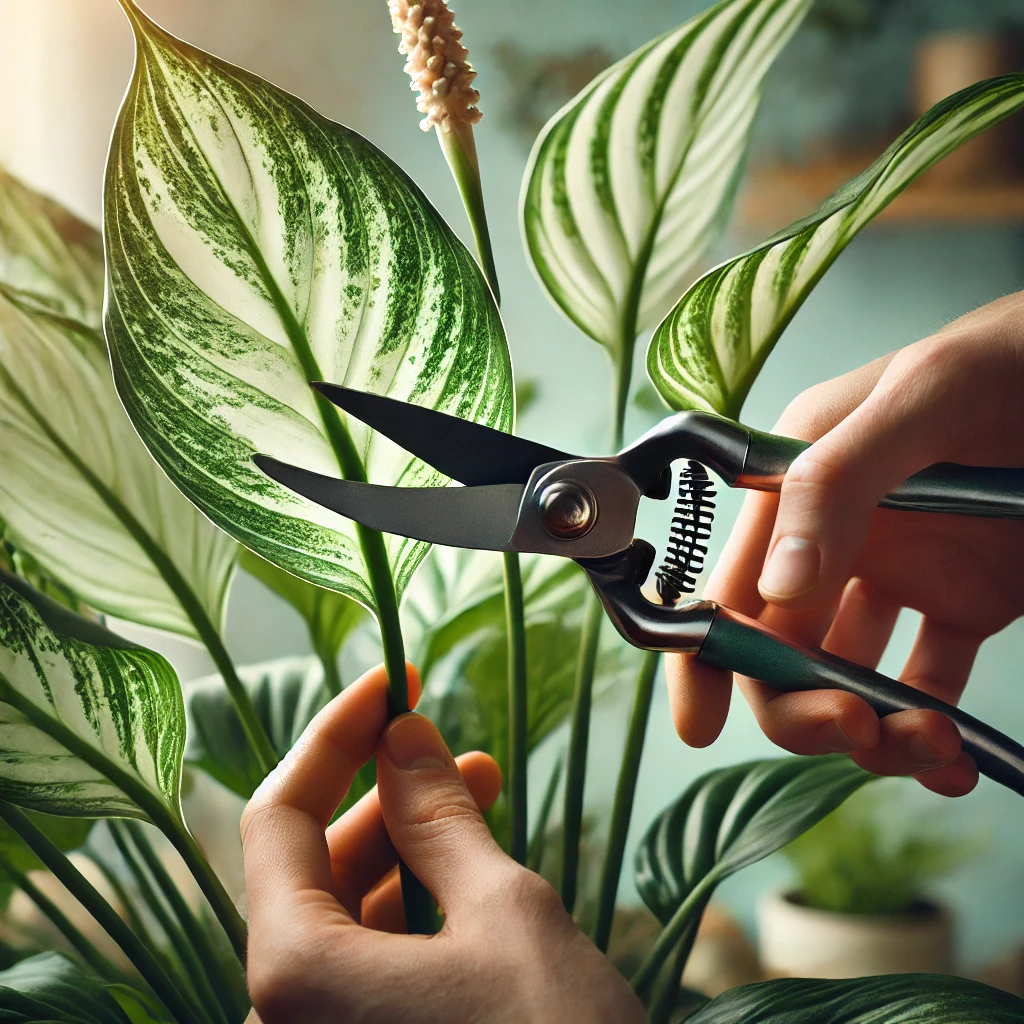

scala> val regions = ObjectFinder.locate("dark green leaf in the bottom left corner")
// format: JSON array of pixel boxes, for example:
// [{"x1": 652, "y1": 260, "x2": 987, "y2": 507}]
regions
[{"x1": 0, "y1": 953, "x2": 140, "y2": 1024}]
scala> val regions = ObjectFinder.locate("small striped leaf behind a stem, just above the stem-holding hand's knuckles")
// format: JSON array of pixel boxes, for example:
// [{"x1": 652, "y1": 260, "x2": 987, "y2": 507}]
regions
[{"x1": 184, "y1": 657, "x2": 332, "y2": 800}]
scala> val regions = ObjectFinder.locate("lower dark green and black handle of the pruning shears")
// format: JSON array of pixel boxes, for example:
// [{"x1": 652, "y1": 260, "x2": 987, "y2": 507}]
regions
[{"x1": 698, "y1": 605, "x2": 1024, "y2": 797}]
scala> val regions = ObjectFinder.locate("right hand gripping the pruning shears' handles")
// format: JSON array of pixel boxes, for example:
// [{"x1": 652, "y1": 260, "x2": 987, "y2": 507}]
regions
[{"x1": 668, "y1": 293, "x2": 1024, "y2": 796}]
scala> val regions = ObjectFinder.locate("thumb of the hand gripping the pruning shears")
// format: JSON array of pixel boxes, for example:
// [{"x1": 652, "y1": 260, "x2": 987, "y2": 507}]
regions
[{"x1": 758, "y1": 378, "x2": 938, "y2": 608}]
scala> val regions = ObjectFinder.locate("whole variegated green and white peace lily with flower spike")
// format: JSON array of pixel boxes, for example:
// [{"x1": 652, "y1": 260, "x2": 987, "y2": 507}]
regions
[{"x1": 0, "y1": 0, "x2": 1024, "y2": 1024}]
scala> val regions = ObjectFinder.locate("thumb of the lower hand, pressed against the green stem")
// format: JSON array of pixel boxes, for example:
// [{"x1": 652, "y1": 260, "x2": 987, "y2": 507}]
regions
[{"x1": 377, "y1": 714, "x2": 513, "y2": 916}]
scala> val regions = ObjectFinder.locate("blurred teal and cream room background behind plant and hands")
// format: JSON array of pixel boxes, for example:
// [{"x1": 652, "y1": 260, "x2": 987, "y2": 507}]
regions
[{"x1": 0, "y1": 0, "x2": 1024, "y2": 995}]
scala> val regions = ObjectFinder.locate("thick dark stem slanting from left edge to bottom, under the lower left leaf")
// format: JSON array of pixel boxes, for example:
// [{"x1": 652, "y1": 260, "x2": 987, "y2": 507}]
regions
[{"x1": 0, "y1": 800, "x2": 201, "y2": 1024}]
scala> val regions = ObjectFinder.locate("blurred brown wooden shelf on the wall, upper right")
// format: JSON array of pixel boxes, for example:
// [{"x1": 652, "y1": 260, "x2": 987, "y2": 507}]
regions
[{"x1": 739, "y1": 157, "x2": 1024, "y2": 231}]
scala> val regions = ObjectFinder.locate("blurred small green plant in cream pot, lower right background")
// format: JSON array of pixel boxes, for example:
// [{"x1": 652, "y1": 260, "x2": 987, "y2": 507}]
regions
[{"x1": 758, "y1": 784, "x2": 977, "y2": 978}]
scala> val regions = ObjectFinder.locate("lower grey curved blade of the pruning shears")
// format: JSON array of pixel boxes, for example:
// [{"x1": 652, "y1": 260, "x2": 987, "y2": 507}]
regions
[{"x1": 253, "y1": 455, "x2": 525, "y2": 551}]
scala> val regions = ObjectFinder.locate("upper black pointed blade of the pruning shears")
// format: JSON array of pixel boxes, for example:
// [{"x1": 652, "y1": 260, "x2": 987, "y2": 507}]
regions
[{"x1": 313, "y1": 383, "x2": 574, "y2": 486}]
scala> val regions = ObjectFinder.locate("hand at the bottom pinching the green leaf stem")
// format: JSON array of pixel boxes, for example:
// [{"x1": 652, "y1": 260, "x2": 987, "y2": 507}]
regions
[{"x1": 242, "y1": 667, "x2": 644, "y2": 1024}]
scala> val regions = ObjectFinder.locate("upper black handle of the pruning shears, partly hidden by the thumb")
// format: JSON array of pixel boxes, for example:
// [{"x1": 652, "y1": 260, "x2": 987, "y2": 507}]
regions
[{"x1": 736, "y1": 430, "x2": 1024, "y2": 519}]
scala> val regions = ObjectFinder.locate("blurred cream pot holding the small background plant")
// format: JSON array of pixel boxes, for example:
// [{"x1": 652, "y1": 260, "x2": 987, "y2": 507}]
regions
[{"x1": 758, "y1": 893, "x2": 953, "y2": 978}]
